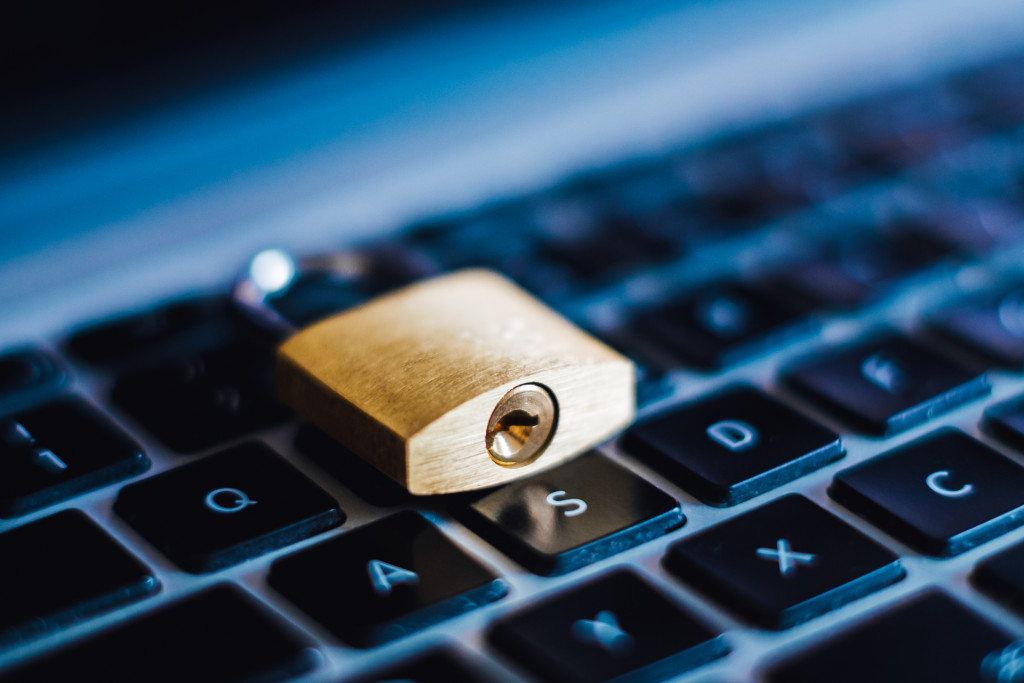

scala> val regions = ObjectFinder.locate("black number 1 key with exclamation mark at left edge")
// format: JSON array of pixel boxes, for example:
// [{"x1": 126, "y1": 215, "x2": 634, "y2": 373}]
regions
[{"x1": 0, "y1": 398, "x2": 150, "y2": 517}]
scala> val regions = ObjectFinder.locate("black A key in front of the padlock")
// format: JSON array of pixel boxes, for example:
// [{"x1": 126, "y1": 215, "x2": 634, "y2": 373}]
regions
[{"x1": 267, "y1": 512, "x2": 507, "y2": 647}]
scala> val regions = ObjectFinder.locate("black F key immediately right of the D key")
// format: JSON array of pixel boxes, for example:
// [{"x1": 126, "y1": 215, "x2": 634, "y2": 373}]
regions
[{"x1": 783, "y1": 336, "x2": 989, "y2": 435}]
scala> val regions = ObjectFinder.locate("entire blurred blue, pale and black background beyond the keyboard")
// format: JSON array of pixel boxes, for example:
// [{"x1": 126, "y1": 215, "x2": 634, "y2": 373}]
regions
[{"x1": 0, "y1": 0, "x2": 1024, "y2": 339}]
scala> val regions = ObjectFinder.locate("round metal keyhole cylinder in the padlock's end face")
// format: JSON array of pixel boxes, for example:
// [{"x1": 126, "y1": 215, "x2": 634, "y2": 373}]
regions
[{"x1": 486, "y1": 384, "x2": 557, "y2": 467}]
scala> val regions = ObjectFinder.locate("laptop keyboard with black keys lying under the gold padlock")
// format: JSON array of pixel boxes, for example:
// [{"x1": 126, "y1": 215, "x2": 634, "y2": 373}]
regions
[{"x1": 0, "y1": 49, "x2": 1024, "y2": 683}]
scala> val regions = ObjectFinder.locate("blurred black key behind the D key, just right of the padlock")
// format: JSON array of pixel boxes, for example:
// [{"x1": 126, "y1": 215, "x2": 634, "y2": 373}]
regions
[{"x1": 633, "y1": 283, "x2": 814, "y2": 369}]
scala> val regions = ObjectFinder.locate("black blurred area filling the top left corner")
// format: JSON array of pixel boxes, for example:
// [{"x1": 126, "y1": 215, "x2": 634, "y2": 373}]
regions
[{"x1": 0, "y1": 0, "x2": 495, "y2": 154}]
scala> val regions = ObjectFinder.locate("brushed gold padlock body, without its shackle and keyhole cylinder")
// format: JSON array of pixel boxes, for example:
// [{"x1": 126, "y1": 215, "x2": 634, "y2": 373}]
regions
[{"x1": 276, "y1": 270, "x2": 636, "y2": 495}]
